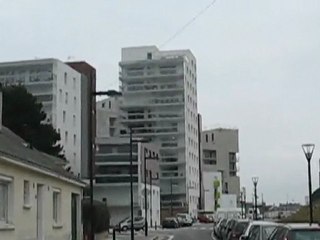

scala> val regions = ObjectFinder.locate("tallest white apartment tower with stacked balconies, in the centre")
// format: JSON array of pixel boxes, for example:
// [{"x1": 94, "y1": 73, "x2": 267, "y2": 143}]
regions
[{"x1": 119, "y1": 46, "x2": 199, "y2": 216}]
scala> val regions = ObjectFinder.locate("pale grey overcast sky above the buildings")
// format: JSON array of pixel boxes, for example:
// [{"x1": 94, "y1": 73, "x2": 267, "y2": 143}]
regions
[{"x1": 0, "y1": 0, "x2": 320, "y2": 203}]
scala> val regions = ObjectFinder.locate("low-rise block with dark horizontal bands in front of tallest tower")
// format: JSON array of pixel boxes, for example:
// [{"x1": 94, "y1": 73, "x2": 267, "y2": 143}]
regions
[{"x1": 94, "y1": 137, "x2": 160, "y2": 225}]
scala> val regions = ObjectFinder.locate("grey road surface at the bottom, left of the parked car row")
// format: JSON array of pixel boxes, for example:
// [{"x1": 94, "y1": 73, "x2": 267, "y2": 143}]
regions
[{"x1": 149, "y1": 224, "x2": 213, "y2": 240}]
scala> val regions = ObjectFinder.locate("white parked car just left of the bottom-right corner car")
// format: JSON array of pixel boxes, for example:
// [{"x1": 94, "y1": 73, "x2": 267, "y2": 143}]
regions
[{"x1": 240, "y1": 221, "x2": 283, "y2": 240}]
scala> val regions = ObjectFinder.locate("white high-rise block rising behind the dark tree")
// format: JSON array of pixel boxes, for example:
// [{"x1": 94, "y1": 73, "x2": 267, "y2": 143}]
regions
[{"x1": 0, "y1": 59, "x2": 87, "y2": 174}]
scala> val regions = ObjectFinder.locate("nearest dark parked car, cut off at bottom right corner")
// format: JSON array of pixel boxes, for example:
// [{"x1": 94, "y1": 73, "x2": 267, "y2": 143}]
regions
[{"x1": 269, "y1": 223, "x2": 320, "y2": 240}]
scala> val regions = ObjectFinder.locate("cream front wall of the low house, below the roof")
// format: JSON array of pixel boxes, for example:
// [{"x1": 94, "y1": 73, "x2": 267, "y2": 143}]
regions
[{"x1": 0, "y1": 161, "x2": 82, "y2": 240}]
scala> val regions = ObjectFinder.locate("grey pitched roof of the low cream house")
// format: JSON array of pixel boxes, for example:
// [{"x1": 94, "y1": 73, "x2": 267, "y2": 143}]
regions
[{"x1": 0, "y1": 126, "x2": 84, "y2": 184}]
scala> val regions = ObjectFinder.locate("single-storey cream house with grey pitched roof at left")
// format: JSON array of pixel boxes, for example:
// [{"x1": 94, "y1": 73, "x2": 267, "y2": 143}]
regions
[{"x1": 0, "y1": 93, "x2": 85, "y2": 240}]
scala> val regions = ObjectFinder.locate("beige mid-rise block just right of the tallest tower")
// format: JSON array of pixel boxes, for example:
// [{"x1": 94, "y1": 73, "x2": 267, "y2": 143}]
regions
[{"x1": 201, "y1": 128, "x2": 240, "y2": 197}]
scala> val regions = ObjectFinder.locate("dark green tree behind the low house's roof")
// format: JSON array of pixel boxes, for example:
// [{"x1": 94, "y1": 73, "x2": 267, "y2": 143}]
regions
[{"x1": 2, "y1": 86, "x2": 63, "y2": 157}]
